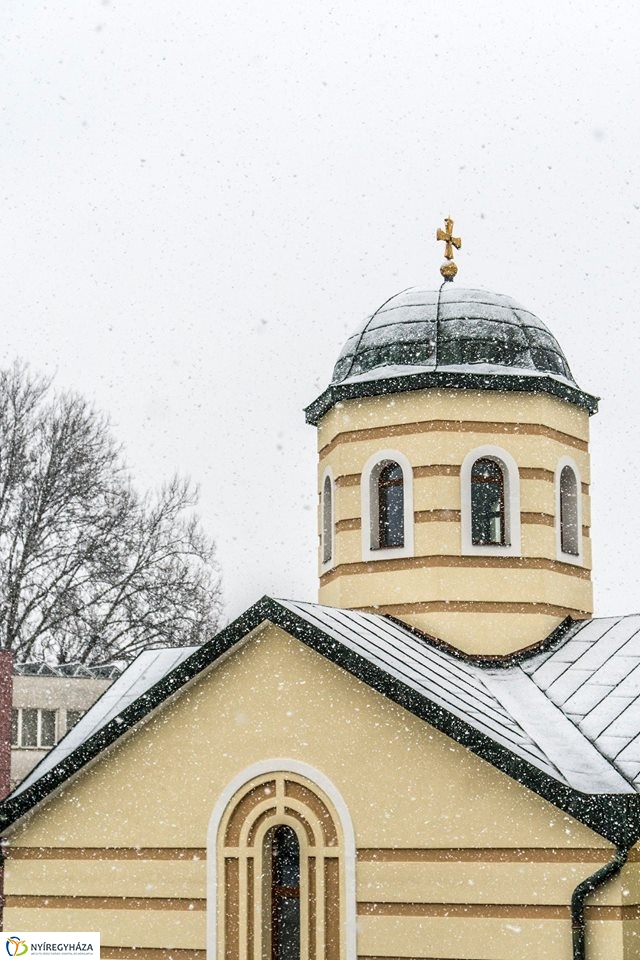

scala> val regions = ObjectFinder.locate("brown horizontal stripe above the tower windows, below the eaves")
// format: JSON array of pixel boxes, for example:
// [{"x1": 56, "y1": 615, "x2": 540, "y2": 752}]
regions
[{"x1": 319, "y1": 420, "x2": 589, "y2": 458}]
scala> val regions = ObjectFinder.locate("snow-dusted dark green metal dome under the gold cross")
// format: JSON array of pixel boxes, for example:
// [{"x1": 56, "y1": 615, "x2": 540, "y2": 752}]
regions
[{"x1": 331, "y1": 283, "x2": 575, "y2": 386}]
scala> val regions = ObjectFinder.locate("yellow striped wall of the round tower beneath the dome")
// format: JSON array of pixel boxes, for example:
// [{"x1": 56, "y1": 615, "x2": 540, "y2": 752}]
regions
[{"x1": 318, "y1": 389, "x2": 593, "y2": 654}]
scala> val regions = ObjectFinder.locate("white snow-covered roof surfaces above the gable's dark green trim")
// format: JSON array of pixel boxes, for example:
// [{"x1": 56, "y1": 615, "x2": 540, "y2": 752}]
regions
[{"x1": 6, "y1": 598, "x2": 640, "y2": 819}]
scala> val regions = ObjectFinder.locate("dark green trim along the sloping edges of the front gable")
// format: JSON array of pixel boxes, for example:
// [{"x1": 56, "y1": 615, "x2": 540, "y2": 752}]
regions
[{"x1": 0, "y1": 597, "x2": 640, "y2": 846}]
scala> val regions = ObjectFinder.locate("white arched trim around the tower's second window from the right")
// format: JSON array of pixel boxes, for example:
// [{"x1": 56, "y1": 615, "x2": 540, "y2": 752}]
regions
[{"x1": 460, "y1": 443, "x2": 522, "y2": 557}]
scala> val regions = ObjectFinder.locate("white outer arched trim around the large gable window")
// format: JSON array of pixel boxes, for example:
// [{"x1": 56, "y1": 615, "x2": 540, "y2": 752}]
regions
[{"x1": 207, "y1": 757, "x2": 357, "y2": 960}]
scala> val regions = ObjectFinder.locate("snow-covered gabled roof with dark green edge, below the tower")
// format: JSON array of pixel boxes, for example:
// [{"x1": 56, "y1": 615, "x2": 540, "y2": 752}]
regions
[{"x1": 0, "y1": 597, "x2": 640, "y2": 846}]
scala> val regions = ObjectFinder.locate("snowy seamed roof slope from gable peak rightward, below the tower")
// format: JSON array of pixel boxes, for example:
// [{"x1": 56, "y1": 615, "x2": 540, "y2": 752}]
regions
[{"x1": 279, "y1": 600, "x2": 640, "y2": 793}]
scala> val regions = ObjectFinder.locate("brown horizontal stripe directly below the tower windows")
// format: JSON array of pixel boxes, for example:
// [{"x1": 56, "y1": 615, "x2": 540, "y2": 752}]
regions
[{"x1": 320, "y1": 554, "x2": 591, "y2": 586}]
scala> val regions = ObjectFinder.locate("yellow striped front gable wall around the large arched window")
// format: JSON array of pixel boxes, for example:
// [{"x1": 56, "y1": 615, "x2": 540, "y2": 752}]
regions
[{"x1": 5, "y1": 625, "x2": 628, "y2": 960}]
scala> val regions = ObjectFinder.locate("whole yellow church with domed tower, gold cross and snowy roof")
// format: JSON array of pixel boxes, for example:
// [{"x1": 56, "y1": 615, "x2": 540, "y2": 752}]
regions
[{"x1": 0, "y1": 227, "x2": 640, "y2": 960}]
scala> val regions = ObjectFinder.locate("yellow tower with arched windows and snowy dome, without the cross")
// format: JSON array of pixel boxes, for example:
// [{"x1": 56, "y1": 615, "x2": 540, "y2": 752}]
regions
[{"x1": 306, "y1": 283, "x2": 597, "y2": 655}]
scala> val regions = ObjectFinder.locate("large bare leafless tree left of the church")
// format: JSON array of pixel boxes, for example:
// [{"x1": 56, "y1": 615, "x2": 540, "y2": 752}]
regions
[{"x1": 0, "y1": 364, "x2": 221, "y2": 664}]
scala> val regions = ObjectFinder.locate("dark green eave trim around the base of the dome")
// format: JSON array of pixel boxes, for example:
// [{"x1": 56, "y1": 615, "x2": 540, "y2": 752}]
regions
[{"x1": 305, "y1": 370, "x2": 598, "y2": 426}]
